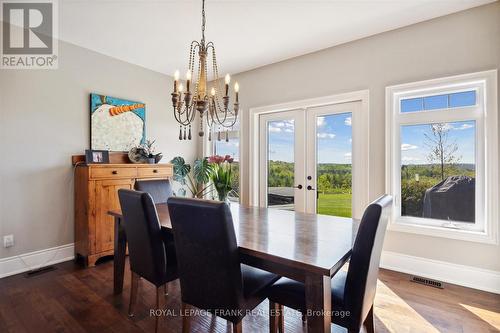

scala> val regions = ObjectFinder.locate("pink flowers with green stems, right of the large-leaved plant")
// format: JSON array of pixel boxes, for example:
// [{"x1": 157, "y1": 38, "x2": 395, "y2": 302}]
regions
[{"x1": 208, "y1": 155, "x2": 234, "y2": 201}]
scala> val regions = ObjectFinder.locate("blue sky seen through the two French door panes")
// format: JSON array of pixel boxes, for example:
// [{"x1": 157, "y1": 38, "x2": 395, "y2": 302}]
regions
[{"x1": 268, "y1": 113, "x2": 352, "y2": 164}]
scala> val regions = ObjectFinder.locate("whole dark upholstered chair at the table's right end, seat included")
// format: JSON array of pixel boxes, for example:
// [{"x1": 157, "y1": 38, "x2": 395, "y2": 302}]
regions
[{"x1": 267, "y1": 195, "x2": 392, "y2": 333}]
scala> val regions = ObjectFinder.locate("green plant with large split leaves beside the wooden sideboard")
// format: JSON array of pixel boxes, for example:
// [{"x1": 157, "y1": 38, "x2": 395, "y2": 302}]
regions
[{"x1": 170, "y1": 156, "x2": 213, "y2": 198}]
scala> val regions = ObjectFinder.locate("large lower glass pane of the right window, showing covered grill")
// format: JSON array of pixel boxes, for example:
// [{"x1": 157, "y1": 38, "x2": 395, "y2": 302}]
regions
[{"x1": 401, "y1": 121, "x2": 476, "y2": 223}]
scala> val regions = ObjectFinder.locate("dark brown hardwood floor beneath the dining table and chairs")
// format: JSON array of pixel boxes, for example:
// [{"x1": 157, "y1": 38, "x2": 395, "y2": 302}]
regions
[{"x1": 0, "y1": 261, "x2": 500, "y2": 333}]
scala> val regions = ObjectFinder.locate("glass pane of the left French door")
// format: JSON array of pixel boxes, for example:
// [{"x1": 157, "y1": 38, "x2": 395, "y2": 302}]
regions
[{"x1": 267, "y1": 120, "x2": 295, "y2": 210}]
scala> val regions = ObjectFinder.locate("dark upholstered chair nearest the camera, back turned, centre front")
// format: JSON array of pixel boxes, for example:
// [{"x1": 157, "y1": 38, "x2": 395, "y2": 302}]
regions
[{"x1": 168, "y1": 197, "x2": 279, "y2": 332}]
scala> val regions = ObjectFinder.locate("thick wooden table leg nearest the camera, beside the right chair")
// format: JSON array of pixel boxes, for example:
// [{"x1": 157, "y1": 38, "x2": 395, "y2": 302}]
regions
[{"x1": 305, "y1": 275, "x2": 332, "y2": 333}]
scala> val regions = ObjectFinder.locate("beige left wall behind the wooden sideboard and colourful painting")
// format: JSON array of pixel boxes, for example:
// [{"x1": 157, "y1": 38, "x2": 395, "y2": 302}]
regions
[{"x1": 0, "y1": 42, "x2": 197, "y2": 258}]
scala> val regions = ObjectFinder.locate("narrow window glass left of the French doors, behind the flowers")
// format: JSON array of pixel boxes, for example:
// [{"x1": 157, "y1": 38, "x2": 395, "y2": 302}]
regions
[{"x1": 211, "y1": 122, "x2": 240, "y2": 201}]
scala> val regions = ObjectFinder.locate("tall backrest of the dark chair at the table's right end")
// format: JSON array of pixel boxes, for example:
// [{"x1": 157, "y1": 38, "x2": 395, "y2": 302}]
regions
[{"x1": 344, "y1": 195, "x2": 392, "y2": 330}]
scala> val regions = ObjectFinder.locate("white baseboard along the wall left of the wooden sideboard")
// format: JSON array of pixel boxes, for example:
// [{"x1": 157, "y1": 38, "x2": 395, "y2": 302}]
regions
[{"x1": 0, "y1": 243, "x2": 75, "y2": 278}]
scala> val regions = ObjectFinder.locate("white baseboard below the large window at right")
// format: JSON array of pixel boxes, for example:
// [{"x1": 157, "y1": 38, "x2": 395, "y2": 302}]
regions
[{"x1": 380, "y1": 251, "x2": 500, "y2": 294}]
